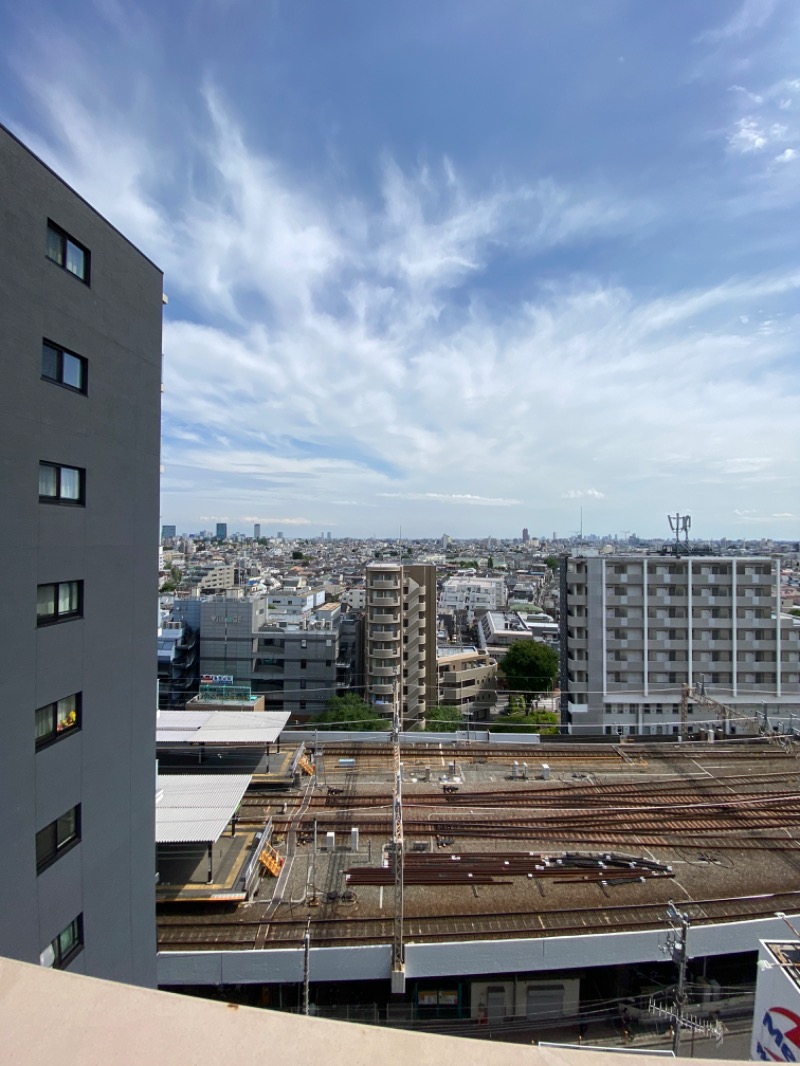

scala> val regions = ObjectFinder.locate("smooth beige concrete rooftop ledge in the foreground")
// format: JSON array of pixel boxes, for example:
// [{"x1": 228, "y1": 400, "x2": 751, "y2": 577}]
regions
[{"x1": 0, "y1": 958, "x2": 742, "y2": 1066}]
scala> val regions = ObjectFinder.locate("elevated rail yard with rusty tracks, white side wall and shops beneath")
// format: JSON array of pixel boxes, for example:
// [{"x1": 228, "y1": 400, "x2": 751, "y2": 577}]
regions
[{"x1": 158, "y1": 733, "x2": 800, "y2": 1034}]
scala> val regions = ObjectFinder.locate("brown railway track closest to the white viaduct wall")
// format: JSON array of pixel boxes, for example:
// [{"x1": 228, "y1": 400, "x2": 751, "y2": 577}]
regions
[{"x1": 158, "y1": 891, "x2": 800, "y2": 951}]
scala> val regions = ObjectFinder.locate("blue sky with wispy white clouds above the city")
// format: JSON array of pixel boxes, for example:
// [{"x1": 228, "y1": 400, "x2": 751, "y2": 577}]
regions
[{"x1": 0, "y1": 0, "x2": 800, "y2": 538}]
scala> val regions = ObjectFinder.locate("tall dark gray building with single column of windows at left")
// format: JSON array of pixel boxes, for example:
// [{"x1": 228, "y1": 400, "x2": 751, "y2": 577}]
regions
[{"x1": 0, "y1": 127, "x2": 162, "y2": 985}]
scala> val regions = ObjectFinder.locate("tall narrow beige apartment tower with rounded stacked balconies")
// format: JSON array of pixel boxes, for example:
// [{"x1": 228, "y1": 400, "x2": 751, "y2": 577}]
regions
[{"x1": 364, "y1": 563, "x2": 438, "y2": 729}]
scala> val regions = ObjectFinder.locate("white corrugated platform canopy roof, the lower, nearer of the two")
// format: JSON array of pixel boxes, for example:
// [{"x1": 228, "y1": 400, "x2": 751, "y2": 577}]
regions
[{"x1": 156, "y1": 774, "x2": 250, "y2": 844}]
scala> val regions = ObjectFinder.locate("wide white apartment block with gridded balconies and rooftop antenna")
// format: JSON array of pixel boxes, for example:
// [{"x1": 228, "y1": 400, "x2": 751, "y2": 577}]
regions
[{"x1": 561, "y1": 555, "x2": 800, "y2": 736}]
